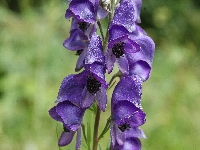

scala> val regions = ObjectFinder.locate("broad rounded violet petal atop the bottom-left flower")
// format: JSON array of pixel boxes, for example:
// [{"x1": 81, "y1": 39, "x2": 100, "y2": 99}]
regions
[{"x1": 56, "y1": 101, "x2": 84, "y2": 131}]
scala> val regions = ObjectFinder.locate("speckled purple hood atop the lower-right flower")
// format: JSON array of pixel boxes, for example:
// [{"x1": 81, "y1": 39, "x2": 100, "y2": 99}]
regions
[{"x1": 111, "y1": 76, "x2": 142, "y2": 108}]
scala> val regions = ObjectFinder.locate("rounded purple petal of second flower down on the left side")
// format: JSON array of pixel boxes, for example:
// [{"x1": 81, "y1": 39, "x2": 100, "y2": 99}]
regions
[{"x1": 63, "y1": 30, "x2": 88, "y2": 51}]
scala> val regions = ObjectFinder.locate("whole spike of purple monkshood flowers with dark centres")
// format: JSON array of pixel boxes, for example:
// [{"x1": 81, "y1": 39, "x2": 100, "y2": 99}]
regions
[{"x1": 49, "y1": 0, "x2": 155, "y2": 150}]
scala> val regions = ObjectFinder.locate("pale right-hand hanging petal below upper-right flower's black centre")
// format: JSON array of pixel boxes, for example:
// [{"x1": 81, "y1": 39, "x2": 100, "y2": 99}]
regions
[{"x1": 116, "y1": 55, "x2": 129, "y2": 75}]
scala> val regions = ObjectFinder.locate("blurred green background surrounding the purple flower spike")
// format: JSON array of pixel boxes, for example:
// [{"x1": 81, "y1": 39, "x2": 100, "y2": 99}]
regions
[{"x1": 0, "y1": 0, "x2": 200, "y2": 150}]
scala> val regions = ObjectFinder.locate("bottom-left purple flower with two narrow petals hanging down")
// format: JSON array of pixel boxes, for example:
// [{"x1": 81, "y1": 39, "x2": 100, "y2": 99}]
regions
[{"x1": 49, "y1": 101, "x2": 85, "y2": 150}]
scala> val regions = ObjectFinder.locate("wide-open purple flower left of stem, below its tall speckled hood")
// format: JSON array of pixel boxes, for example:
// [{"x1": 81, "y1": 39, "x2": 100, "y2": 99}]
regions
[{"x1": 56, "y1": 63, "x2": 108, "y2": 111}]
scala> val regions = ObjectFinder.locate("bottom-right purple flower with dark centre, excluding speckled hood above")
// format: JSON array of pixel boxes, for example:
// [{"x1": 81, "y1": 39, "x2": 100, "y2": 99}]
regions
[{"x1": 110, "y1": 100, "x2": 146, "y2": 150}]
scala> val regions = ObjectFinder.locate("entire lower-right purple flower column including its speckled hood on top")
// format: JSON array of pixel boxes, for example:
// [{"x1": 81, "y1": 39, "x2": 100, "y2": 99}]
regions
[{"x1": 110, "y1": 75, "x2": 146, "y2": 150}]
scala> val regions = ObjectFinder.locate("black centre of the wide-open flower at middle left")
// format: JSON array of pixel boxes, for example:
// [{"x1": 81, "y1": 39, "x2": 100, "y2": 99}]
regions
[{"x1": 87, "y1": 76, "x2": 101, "y2": 95}]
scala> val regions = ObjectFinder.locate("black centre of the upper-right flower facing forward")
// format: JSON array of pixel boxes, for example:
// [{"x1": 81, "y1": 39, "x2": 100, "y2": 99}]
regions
[{"x1": 112, "y1": 42, "x2": 125, "y2": 58}]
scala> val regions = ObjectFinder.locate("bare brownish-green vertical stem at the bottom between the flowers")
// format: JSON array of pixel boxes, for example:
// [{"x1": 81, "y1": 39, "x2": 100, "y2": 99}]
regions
[{"x1": 92, "y1": 105, "x2": 101, "y2": 150}]
